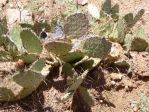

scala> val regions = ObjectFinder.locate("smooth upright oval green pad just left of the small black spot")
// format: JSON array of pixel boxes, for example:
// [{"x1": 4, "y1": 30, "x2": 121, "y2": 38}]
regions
[{"x1": 20, "y1": 29, "x2": 43, "y2": 54}]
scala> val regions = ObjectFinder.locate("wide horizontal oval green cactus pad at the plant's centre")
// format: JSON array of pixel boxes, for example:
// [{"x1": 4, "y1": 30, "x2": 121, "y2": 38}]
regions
[{"x1": 44, "y1": 41, "x2": 72, "y2": 55}]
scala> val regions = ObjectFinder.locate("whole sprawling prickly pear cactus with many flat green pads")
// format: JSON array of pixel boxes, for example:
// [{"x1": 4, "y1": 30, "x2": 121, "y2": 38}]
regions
[{"x1": 0, "y1": 0, "x2": 149, "y2": 106}]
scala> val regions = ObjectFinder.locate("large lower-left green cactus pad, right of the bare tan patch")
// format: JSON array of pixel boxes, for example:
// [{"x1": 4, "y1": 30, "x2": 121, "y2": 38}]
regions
[{"x1": 13, "y1": 70, "x2": 45, "y2": 99}]
